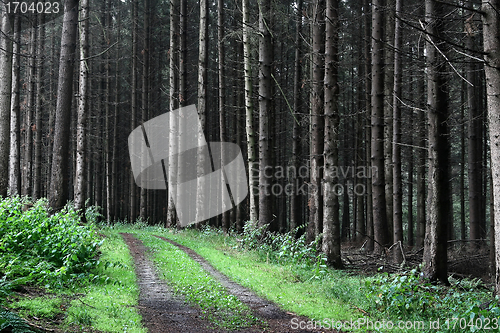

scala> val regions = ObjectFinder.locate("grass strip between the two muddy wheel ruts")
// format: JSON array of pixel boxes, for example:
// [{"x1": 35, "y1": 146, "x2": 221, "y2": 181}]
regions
[{"x1": 131, "y1": 229, "x2": 258, "y2": 329}]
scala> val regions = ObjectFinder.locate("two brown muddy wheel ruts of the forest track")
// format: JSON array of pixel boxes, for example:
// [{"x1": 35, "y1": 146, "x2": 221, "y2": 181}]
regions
[{"x1": 122, "y1": 233, "x2": 336, "y2": 333}]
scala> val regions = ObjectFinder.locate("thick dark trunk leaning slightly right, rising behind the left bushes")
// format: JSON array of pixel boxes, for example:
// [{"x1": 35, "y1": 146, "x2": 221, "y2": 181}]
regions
[{"x1": 49, "y1": 0, "x2": 78, "y2": 210}]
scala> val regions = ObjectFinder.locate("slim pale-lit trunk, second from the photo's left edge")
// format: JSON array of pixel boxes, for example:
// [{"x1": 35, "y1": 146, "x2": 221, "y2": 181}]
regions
[{"x1": 9, "y1": 15, "x2": 21, "y2": 195}]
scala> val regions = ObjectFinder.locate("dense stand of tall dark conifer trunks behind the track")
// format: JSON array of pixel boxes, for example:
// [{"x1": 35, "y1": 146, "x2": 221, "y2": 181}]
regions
[{"x1": 0, "y1": 0, "x2": 500, "y2": 329}]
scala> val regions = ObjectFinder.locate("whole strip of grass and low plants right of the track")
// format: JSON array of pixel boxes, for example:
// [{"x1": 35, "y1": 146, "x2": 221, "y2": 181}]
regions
[{"x1": 143, "y1": 229, "x2": 500, "y2": 332}]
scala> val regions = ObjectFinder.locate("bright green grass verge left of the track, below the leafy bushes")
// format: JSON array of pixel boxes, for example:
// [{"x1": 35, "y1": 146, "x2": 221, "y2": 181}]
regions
[{"x1": 9, "y1": 231, "x2": 147, "y2": 333}]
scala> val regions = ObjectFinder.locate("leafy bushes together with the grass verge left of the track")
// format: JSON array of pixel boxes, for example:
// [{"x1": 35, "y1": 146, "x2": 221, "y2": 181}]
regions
[{"x1": 0, "y1": 196, "x2": 145, "y2": 332}]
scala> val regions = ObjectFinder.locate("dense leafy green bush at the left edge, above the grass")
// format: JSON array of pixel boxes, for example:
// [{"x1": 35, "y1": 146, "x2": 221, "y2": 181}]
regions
[{"x1": 0, "y1": 197, "x2": 101, "y2": 285}]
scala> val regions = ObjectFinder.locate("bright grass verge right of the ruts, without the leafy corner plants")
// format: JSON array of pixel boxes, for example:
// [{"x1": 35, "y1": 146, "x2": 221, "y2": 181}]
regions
[{"x1": 150, "y1": 230, "x2": 366, "y2": 320}]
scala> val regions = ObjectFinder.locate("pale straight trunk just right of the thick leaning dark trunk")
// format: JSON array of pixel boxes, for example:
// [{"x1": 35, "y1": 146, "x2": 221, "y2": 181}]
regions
[{"x1": 74, "y1": 0, "x2": 89, "y2": 210}]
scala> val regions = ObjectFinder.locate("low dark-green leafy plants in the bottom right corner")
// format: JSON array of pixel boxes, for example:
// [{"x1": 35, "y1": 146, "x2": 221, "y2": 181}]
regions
[{"x1": 366, "y1": 269, "x2": 500, "y2": 332}]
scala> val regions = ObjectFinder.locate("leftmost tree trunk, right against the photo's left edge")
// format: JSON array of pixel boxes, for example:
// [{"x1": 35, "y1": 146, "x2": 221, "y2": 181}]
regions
[{"x1": 0, "y1": 5, "x2": 13, "y2": 197}]
